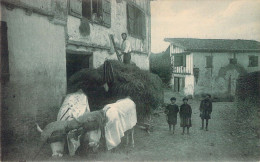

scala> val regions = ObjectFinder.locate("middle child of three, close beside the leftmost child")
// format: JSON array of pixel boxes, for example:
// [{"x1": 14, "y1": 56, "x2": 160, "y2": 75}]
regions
[{"x1": 180, "y1": 97, "x2": 192, "y2": 135}]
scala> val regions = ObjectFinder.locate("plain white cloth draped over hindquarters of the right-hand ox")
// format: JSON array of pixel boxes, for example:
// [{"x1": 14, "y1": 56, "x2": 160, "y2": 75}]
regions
[{"x1": 104, "y1": 98, "x2": 137, "y2": 150}]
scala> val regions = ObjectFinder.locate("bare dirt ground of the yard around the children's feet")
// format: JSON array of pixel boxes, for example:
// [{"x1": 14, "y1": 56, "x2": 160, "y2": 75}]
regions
[{"x1": 2, "y1": 90, "x2": 260, "y2": 161}]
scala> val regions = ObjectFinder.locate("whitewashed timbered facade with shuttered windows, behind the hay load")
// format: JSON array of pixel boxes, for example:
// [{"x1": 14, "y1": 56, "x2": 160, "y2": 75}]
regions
[{"x1": 67, "y1": 0, "x2": 151, "y2": 70}]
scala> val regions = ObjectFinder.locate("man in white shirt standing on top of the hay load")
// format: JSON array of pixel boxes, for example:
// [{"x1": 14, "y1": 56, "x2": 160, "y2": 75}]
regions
[{"x1": 121, "y1": 33, "x2": 131, "y2": 64}]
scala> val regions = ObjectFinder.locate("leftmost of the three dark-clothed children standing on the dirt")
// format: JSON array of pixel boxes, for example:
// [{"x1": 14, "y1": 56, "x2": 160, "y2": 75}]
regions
[{"x1": 165, "y1": 97, "x2": 179, "y2": 134}]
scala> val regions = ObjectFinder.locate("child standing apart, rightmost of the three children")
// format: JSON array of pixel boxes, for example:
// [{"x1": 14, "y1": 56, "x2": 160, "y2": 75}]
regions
[{"x1": 200, "y1": 94, "x2": 212, "y2": 131}]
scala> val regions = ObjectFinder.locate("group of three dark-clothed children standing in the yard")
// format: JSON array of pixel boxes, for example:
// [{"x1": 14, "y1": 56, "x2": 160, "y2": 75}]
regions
[{"x1": 165, "y1": 94, "x2": 212, "y2": 135}]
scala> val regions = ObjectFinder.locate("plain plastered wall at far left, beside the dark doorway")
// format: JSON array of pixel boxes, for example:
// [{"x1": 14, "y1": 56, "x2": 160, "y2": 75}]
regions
[{"x1": 1, "y1": 5, "x2": 66, "y2": 114}]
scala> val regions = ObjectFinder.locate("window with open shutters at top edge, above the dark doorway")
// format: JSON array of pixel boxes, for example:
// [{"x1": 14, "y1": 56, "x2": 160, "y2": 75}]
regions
[{"x1": 69, "y1": 0, "x2": 111, "y2": 27}]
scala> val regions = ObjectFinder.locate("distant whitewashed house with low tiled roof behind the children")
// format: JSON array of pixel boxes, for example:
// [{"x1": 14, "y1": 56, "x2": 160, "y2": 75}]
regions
[{"x1": 165, "y1": 38, "x2": 260, "y2": 98}]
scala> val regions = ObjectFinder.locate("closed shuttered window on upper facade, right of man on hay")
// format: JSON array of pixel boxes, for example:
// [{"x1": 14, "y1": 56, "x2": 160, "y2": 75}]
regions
[{"x1": 127, "y1": 4, "x2": 146, "y2": 39}]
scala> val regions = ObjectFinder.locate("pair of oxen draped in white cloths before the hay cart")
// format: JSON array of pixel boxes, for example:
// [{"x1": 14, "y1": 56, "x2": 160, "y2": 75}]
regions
[{"x1": 37, "y1": 90, "x2": 137, "y2": 156}]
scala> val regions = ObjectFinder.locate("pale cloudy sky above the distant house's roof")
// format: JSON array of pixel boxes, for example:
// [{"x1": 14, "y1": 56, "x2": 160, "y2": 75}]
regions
[{"x1": 151, "y1": 0, "x2": 260, "y2": 53}]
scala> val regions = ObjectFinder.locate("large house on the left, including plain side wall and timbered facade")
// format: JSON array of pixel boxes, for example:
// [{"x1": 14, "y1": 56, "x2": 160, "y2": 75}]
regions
[{"x1": 0, "y1": 0, "x2": 151, "y2": 115}]
